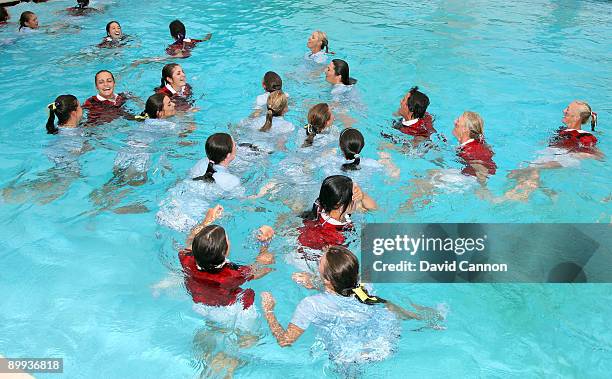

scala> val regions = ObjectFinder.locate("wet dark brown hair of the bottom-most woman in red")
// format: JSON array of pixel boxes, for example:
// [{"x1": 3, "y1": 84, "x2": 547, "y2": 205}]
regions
[{"x1": 191, "y1": 225, "x2": 229, "y2": 273}]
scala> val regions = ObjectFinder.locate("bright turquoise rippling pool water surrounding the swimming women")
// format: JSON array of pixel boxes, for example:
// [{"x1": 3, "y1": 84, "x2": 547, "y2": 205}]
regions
[{"x1": 0, "y1": 0, "x2": 612, "y2": 378}]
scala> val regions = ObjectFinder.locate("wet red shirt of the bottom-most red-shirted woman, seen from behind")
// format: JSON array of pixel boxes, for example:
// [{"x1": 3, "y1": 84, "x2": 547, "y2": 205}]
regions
[{"x1": 179, "y1": 249, "x2": 255, "y2": 309}]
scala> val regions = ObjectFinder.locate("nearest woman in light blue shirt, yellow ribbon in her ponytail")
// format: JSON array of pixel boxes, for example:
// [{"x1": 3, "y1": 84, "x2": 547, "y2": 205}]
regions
[{"x1": 262, "y1": 246, "x2": 442, "y2": 364}]
